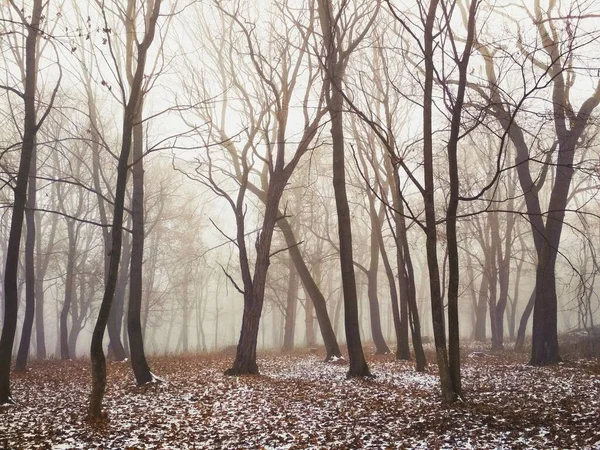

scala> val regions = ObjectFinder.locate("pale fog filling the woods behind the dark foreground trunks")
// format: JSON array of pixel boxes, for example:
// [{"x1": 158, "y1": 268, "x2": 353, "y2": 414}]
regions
[{"x1": 0, "y1": 1, "x2": 600, "y2": 390}]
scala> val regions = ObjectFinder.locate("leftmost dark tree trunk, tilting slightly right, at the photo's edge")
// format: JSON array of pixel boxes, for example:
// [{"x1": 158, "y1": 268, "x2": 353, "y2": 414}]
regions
[{"x1": 0, "y1": 0, "x2": 44, "y2": 405}]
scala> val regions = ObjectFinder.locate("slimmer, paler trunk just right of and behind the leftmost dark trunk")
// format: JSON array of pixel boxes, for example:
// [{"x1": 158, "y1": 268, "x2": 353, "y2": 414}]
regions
[{"x1": 15, "y1": 145, "x2": 37, "y2": 372}]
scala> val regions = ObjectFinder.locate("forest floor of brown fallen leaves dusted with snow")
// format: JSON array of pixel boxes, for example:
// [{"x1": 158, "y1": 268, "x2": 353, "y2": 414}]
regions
[{"x1": 0, "y1": 342, "x2": 600, "y2": 450}]
